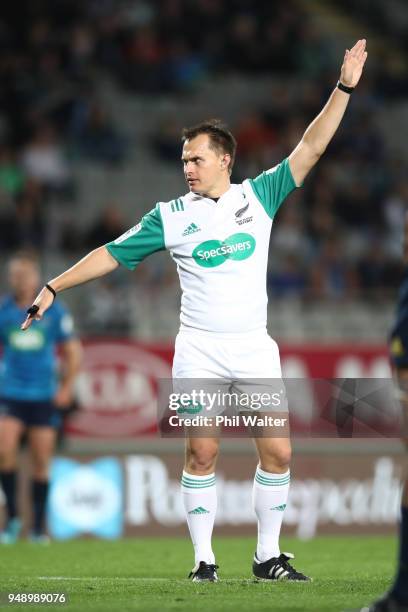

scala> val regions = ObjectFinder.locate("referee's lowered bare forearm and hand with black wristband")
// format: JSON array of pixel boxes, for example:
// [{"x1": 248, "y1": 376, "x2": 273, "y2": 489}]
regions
[{"x1": 21, "y1": 246, "x2": 119, "y2": 330}]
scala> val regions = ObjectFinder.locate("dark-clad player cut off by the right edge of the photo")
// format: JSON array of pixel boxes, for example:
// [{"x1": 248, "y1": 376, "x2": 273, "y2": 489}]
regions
[{"x1": 363, "y1": 221, "x2": 408, "y2": 612}]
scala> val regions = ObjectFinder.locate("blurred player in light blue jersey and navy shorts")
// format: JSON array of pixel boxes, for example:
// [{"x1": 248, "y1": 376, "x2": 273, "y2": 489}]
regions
[{"x1": 0, "y1": 252, "x2": 81, "y2": 543}]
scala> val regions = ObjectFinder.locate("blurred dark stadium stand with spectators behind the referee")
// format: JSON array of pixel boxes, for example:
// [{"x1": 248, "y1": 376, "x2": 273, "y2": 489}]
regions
[{"x1": 0, "y1": 0, "x2": 408, "y2": 340}]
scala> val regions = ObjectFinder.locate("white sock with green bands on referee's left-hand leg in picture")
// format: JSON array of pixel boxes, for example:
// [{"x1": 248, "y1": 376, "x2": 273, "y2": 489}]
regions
[{"x1": 181, "y1": 471, "x2": 217, "y2": 563}]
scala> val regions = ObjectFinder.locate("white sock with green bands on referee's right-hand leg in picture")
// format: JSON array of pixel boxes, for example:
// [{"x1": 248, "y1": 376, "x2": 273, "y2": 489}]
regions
[{"x1": 253, "y1": 466, "x2": 290, "y2": 562}]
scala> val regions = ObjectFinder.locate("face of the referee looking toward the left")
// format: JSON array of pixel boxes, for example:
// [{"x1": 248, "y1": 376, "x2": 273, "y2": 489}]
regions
[{"x1": 181, "y1": 134, "x2": 230, "y2": 196}]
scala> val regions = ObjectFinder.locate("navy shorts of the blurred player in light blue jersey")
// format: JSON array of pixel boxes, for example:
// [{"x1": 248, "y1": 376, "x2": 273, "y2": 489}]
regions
[{"x1": 0, "y1": 398, "x2": 62, "y2": 429}]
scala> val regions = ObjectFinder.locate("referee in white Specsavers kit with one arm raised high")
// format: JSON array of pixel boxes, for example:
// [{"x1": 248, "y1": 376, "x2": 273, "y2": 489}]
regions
[{"x1": 22, "y1": 39, "x2": 367, "y2": 582}]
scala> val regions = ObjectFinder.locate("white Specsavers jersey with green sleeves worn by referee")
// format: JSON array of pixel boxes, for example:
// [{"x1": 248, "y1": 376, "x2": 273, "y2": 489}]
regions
[{"x1": 106, "y1": 159, "x2": 296, "y2": 333}]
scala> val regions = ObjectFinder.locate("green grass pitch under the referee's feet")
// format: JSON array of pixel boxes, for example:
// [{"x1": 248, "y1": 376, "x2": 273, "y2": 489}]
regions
[{"x1": 0, "y1": 537, "x2": 396, "y2": 612}]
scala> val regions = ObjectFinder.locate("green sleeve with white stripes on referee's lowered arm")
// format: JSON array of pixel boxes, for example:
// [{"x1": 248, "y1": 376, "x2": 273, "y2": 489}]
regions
[{"x1": 105, "y1": 204, "x2": 166, "y2": 270}]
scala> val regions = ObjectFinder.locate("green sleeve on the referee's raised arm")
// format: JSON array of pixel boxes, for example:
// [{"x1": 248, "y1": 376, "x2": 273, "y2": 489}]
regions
[{"x1": 249, "y1": 158, "x2": 296, "y2": 219}]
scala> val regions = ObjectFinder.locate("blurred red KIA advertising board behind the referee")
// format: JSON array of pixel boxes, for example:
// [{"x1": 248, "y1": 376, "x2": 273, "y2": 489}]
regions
[{"x1": 66, "y1": 339, "x2": 390, "y2": 439}]
